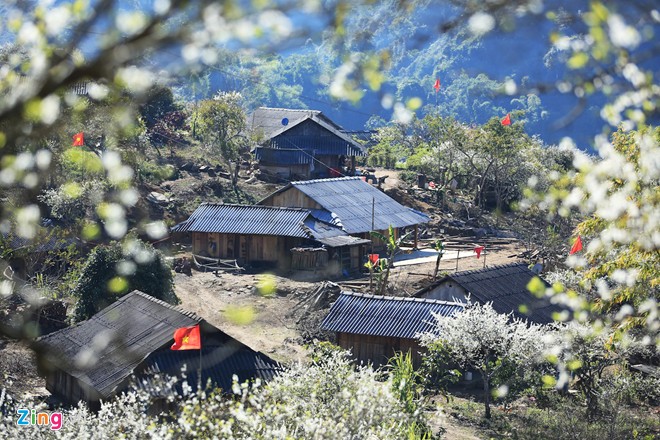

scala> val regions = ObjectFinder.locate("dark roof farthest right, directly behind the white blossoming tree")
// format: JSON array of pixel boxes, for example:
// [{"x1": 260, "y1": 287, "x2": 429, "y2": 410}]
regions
[{"x1": 415, "y1": 263, "x2": 563, "y2": 324}]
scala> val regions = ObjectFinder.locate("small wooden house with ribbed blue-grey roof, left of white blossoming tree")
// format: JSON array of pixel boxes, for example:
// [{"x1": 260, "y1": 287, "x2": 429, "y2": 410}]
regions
[{"x1": 321, "y1": 292, "x2": 464, "y2": 367}]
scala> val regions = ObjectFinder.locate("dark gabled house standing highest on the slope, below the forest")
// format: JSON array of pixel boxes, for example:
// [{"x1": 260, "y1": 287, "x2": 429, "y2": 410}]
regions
[{"x1": 248, "y1": 107, "x2": 366, "y2": 180}]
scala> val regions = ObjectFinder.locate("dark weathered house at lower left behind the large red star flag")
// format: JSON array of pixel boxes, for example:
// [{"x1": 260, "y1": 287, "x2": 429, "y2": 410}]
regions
[{"x1": 36, "y1": 290, "x2": 281, "y2": 408}]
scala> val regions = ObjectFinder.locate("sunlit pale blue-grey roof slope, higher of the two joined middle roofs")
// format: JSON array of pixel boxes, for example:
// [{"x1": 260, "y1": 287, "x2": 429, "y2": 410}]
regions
[{"x1": 268, "y1": 177, "x2": 429, "y2": 234}]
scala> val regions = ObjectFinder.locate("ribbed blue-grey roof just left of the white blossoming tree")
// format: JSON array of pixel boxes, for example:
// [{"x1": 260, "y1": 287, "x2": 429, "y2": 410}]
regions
[{"x1": 321, "y1": 292, "x2": 464, "y2": 339}]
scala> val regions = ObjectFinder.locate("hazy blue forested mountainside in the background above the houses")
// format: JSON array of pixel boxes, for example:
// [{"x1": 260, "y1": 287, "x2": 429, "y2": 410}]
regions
[{"x1": 162, "y1": 1, "x2": 660, "y2": 150}]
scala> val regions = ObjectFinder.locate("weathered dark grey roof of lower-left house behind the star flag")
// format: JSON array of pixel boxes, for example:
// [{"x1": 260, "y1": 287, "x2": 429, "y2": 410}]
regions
[{"x1": 37, "y1": 291, "x2": 279, "y2": 399}]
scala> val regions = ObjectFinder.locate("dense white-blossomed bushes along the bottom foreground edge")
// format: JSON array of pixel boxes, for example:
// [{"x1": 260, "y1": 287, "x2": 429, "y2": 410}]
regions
[{"x1": 0, "y1": 351, "x2": 420, "y2": 440}]
